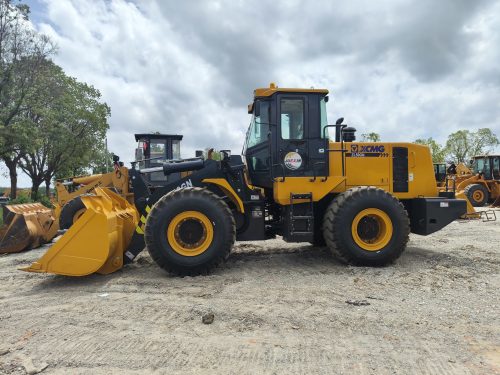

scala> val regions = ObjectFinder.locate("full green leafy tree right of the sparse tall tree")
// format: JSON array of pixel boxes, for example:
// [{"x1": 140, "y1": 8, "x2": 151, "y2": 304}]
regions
[{"x1": 19, "y1": 61, "x2": 110, "y2": 199}]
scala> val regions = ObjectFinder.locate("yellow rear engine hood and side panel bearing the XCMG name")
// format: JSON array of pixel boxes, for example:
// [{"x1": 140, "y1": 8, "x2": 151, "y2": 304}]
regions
[{"x1": 273, "y1": 142, "x2": 438, "y2": 205}]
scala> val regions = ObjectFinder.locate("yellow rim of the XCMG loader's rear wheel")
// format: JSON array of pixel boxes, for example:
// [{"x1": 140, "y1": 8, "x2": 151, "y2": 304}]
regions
[{"x1": 351, "y1": 208, "x2": 393, "y2": 251}]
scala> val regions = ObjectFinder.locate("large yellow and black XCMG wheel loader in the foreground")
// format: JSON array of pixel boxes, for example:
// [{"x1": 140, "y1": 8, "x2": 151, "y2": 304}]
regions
[{"x1": 24, "y1": 84, "x2": 466, "y2": 276}]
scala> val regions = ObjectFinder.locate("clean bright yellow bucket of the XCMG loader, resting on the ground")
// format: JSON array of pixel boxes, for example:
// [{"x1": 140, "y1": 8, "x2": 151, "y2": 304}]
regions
[{"x1": 22, "y1": 188, "x2": 138, "y2": 276}]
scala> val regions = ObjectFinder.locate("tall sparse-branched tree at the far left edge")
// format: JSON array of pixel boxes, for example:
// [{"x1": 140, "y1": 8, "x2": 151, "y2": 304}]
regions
[{"x1": 0, "y1": 0, "x2": 55, "y2": 198}]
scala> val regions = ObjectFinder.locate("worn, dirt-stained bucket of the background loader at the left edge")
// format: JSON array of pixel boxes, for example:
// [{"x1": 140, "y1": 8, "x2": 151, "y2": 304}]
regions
[{"x1": 0, "y1": 203, "x2": 59, "y2": 253}]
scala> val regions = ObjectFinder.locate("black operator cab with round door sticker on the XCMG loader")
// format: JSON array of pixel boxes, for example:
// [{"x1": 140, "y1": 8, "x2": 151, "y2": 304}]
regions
[{"x1": 242, "y1": 83, "x2": 348, "y2": 189}]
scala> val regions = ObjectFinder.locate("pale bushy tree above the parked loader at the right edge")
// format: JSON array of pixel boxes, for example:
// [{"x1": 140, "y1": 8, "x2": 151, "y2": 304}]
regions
[{"x1": 446, "y1": 128, "x2": 500, "y2": 164}]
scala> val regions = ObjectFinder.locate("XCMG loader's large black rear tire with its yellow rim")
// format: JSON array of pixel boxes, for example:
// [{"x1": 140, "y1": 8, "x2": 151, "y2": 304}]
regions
[{"x1": 323, "y1": 187, "x2": 410, "y2": 266}]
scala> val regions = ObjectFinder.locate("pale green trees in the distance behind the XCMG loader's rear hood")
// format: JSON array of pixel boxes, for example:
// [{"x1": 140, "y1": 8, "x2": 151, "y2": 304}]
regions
[{"x1": 361, "y1": 128, "x2": 500, "y2": 164}]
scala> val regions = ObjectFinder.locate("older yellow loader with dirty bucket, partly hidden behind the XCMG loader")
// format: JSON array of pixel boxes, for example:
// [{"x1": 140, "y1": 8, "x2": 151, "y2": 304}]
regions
[{"x1": 0, "y1": 134, "x2": 182, "y2": 253}]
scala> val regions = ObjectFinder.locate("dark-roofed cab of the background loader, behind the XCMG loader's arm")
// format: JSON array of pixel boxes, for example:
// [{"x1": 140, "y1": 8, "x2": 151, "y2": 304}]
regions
[{"x1": 135, "y1": 134, "x2": 182, "y2": 186}]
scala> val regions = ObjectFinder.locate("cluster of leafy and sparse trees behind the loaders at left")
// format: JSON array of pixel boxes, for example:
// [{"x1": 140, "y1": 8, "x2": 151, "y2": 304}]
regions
[{"x1": 0, "y1": 0, "x2": 110, "y2": 199}]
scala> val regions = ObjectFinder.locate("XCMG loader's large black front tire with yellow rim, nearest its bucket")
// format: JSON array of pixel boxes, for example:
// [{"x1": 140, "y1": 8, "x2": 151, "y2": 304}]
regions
[{"x1": 144, "y1": 188, "x2": 236, "y2": 276}]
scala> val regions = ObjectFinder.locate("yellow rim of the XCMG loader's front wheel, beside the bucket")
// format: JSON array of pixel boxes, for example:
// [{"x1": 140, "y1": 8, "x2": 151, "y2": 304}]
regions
[{"x1": 167, "y1": 211, "x2": 214, "y2": 257}]
